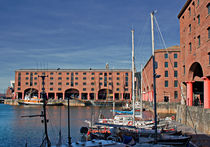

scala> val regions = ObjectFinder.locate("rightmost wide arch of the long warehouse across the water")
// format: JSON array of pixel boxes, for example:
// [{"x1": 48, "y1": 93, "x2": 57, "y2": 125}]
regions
[{"x1": 98, "y1": 89, "x2": 113, "y2": 100}]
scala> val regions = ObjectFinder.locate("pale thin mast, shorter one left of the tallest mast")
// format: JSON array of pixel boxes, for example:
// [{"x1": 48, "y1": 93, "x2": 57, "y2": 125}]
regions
[{"x1": 131, "y1": 29, "x2": 135, "y2": 126}]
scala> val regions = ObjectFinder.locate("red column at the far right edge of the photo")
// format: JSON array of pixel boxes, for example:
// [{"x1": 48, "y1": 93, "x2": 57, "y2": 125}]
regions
[{"x1": 203, "y1": 77, "x2": 210, "y2": 109}]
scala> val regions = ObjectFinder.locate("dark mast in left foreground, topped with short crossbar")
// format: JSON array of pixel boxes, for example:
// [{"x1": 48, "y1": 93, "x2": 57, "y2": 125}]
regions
[{"x1": 39, "y1": 75, "x2": 51, "y2": 147}]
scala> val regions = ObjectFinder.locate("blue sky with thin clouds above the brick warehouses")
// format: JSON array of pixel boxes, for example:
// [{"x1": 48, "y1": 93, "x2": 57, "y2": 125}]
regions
[{"x1": 0, "y1": 0, "x2": 186, "y2": 92}]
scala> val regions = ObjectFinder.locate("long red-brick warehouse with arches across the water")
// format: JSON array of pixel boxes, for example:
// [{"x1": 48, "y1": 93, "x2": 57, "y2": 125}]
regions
[{"x1": 14, "y1": 69, "x2": 132, "y2": 101}]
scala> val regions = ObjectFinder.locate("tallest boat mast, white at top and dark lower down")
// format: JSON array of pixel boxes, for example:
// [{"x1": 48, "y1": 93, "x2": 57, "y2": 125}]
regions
[{"x1": 150, "y1": 12, "x2": 157, "y2": 143}]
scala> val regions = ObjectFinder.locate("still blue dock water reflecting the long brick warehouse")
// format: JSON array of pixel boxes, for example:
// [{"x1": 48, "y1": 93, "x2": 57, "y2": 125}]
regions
[{"x1": 0, "y1": 104, "x2": 112, "y2": 147}]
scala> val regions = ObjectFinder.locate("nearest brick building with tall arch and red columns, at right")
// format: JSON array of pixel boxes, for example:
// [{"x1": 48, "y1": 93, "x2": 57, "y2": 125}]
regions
[{"x1": 178, "y1": 0, "x2": 210, "y2": 108}]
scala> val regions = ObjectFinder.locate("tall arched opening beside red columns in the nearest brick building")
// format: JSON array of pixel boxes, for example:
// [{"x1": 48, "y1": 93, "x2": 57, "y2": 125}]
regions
[{"x1": 187, "y1": 62, "x2": 204, "y2": 106}]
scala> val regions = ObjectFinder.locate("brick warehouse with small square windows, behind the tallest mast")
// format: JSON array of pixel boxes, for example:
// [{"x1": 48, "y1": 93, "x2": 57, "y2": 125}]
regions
[{"x1": 142, "y1": 46, "x2": 181, "y2": 102}]
